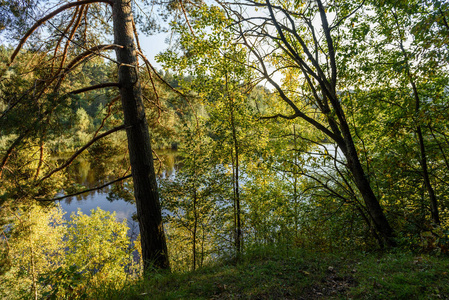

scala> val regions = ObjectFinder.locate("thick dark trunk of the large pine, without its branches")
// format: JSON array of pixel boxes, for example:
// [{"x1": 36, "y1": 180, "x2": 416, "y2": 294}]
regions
[{"x1": 113, "y1": 0, "x2": 170, "y2": 272}]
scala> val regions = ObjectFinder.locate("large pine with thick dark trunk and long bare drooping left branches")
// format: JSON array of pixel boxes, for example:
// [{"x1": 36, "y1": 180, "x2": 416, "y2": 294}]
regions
[{"x1": 0, "y1": 0, "x2": 169, "y2": 272}]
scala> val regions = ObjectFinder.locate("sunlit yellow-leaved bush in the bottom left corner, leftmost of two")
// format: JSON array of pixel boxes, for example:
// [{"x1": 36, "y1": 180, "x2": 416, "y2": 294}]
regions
[{"x1": 0, "y1": 204, "x2": 65, "y2": 299}]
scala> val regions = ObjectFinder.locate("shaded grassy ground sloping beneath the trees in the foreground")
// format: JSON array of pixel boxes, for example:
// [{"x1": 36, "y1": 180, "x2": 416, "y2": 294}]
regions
[{"x1": 109, "y1": 249, "x2": 449, "y2": 300}]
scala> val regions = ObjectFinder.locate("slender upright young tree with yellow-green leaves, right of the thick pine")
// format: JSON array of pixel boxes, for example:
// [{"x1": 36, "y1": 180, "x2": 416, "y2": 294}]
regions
[{"x1": 159, "y1": 6, "x2": 265, "y2": 255}]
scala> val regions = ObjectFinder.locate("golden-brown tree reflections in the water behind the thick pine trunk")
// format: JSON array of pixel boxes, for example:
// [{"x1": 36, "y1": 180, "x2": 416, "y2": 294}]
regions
[{"x1": 57, "y1": 150, "x2": 182, "y2": 204}]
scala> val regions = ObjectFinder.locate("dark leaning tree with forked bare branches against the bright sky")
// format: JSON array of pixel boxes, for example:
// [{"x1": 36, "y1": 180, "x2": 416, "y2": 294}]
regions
[{"x1": 219, "y1": 0, "x2": 396, "y2": 246}]
